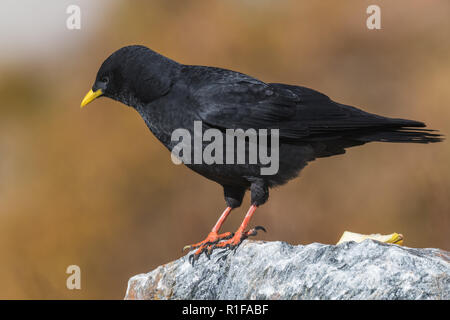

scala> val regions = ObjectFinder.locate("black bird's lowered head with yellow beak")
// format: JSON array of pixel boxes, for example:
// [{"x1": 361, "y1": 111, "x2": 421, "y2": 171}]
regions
[{"x1": 81, "y1": 45, "x2": 178, "y2": 108}]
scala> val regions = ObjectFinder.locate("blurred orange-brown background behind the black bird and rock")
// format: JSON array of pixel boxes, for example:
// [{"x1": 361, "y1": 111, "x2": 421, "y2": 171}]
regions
[{"x1": 0, "y1": 0, "x2": 450, "y2": 299}]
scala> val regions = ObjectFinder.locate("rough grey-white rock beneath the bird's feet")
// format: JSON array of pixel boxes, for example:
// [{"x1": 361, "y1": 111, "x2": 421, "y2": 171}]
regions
[{"x1": 125, "y1": 240, "x2": 450, "y2": 299}]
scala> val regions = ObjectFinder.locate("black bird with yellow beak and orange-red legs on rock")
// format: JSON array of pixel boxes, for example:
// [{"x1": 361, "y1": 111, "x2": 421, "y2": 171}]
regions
[{"x1": 81, "y1": 45, "x2": 441, "y2": 259}]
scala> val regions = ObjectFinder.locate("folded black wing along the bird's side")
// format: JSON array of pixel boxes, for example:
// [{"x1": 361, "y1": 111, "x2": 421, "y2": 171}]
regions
[{"x1": 194, "y1": 68, "x2": 425, "y2": 140}]
